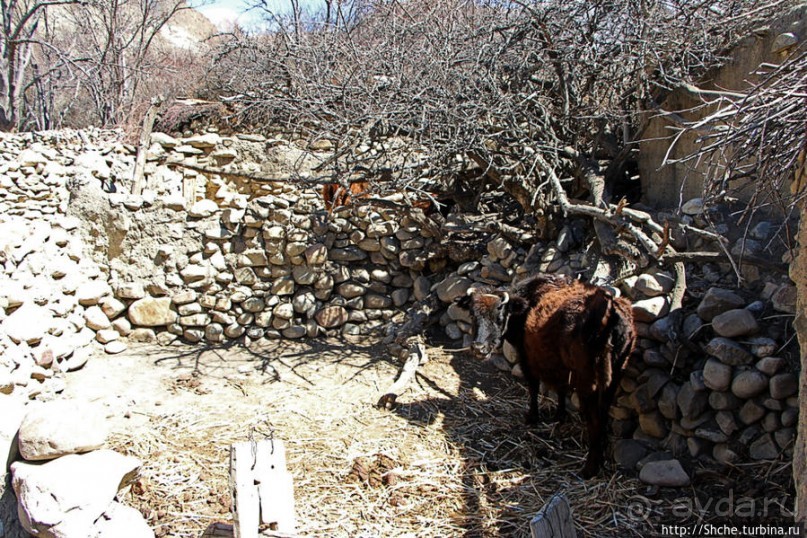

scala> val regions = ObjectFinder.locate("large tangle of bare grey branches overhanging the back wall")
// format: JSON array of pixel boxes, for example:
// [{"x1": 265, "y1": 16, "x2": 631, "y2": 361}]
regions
[{"x1": 204, "y1": 0, "x2": 803, "y2": 276}]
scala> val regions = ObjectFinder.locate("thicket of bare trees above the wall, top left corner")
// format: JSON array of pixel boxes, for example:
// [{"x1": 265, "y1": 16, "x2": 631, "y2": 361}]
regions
[{"x1": 5, "y1": 0, "x2": 207, "y2": 129}]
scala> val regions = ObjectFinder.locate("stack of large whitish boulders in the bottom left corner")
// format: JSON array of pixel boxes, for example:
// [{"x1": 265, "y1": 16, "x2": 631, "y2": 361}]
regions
[{"x1": 6, "y1": 400, "x2": 154, "y2": 538}]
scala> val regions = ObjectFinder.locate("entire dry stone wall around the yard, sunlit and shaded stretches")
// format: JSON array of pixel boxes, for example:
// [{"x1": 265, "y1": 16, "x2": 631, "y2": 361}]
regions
[{"x1": 0, "y1": 126, "x2": 798, "y2": 532}]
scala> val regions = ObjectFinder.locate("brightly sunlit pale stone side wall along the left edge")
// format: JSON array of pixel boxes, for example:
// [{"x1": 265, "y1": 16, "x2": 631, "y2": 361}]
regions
[{"x1": 0, "y1": 131, "x2": 128, "y2": 399}]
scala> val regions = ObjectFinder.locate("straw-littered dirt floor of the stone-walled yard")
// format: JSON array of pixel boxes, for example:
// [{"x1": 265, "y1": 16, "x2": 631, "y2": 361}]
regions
[{"x1": 66, "y1": 341, "x2": 792, "y2": 538}]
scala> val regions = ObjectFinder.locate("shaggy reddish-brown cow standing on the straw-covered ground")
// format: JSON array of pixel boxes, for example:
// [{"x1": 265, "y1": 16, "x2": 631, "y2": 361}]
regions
[{"x1": 458, "y1": 274, "x2": 636, "y2": 478}]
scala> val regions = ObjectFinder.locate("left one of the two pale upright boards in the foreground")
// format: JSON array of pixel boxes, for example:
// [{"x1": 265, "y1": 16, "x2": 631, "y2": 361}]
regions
[{"x1": 230, "y1": 441, "x2": 260, "y2": 538}]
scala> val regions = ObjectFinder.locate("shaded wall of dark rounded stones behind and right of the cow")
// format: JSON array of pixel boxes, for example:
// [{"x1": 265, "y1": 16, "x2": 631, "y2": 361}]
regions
[{"x1": 436, "y1": 218, "x2": 799, "y2": 486}]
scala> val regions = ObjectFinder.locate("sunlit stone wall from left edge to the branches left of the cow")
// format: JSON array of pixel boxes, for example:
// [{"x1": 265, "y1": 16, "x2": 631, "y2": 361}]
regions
[{"x1": 0, "y1": 127, "x2": 446, "y2": 388}]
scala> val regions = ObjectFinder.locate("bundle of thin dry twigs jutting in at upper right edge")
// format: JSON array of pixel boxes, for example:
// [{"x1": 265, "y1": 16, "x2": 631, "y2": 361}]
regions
[{"x1": 665, "y1": 44, "x2": 807, "y2": 214}]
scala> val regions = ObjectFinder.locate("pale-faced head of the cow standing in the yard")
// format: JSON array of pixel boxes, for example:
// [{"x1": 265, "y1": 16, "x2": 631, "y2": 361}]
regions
[{"x1": 456, "y1": 288, "x2": 512, "y2": 358}]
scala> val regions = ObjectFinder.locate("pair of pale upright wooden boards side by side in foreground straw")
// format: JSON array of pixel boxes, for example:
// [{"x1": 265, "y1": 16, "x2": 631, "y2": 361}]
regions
[{"x1": 230, "y1": 439, "x2": 297, "y2": 538}]
